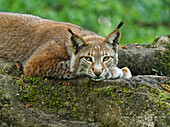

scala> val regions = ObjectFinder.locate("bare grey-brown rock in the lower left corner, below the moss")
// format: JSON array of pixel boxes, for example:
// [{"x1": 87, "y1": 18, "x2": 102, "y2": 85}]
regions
[{"x1": 0, "y1": 71, "x2": 101, "y2": 127}]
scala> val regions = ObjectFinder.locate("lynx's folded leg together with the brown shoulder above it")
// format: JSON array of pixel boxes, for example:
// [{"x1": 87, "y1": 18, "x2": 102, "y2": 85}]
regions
[{"x1": 24, "y1": 41, "x2": 74, "y2": 79}]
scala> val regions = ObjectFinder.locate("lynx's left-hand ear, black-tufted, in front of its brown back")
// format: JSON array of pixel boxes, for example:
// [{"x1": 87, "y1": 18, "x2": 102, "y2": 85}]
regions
[{"x1": 68, "y1": 29, "x2": 86, "y2": 54}]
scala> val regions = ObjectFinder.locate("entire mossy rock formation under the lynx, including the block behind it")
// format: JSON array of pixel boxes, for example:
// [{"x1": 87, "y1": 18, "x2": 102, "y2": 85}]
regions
[{"x1": 0, "y1": 36, "x2": 170, "y2": 127}]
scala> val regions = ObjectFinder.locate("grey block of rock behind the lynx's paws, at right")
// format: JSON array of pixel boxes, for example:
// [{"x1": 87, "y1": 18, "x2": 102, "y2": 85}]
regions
[{"x1": 118, "y1": 37, "x2": 170, "y2": 76}]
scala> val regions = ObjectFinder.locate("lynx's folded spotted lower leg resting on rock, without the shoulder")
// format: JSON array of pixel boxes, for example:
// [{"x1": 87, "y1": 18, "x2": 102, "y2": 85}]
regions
[{"x1": 24, "y1": 54, "x2": 74, "y2": 79}]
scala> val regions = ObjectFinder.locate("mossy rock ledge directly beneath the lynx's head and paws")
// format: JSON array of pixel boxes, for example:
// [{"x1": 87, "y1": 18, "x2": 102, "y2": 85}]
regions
[{"x1": 13, "y1": 76, "x2": 170, "y2": 126}]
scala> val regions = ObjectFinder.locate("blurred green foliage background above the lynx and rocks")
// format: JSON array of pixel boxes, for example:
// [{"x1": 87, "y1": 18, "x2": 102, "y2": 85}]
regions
[{"x1": 0, "y1": 0, "x2": 170, "y2": 44}]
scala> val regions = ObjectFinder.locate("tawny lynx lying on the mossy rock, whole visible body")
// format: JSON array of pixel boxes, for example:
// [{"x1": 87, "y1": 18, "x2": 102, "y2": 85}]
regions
[{"x1": 0, "y1": 12, "x2": 132, "y2": 81}]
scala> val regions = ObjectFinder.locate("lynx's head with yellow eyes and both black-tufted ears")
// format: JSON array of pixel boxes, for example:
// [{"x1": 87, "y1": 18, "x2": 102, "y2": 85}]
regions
[{"x1": 69, "y1": 22, "x2": 123, "y2": 81}]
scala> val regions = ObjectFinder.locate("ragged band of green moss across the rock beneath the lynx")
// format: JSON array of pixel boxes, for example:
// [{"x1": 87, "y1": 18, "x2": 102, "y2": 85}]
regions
[{"x1": 13, "y1": 76, "x2": 169, "y2": 123}]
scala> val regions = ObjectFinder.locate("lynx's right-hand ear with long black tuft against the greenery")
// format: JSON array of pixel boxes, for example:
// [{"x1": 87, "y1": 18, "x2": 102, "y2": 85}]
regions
[{"x1": 106, "y1": 21, "x2": 124, "y2": 53}]
